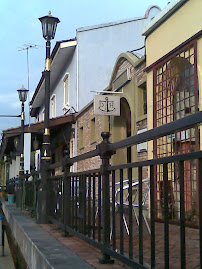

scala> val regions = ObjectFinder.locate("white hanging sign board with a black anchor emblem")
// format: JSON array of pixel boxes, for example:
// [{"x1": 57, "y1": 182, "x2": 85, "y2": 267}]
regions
[{"x1": 94, "y1": 95, "x2": 120, "y2": 116}]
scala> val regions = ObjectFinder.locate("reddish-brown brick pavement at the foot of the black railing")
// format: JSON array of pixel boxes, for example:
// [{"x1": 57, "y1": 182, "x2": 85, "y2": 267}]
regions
[{"x1": 40, "y1": 220, "x2": 200, "y2": 269}]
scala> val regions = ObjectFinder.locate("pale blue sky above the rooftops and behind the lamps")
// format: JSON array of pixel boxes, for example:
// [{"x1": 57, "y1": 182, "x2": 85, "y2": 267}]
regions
[{"x1": 0, "y1": 0, "x2": 169, "y2": 133}]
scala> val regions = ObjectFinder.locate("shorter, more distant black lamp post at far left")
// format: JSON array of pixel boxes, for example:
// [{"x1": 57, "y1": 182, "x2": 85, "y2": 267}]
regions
[{"x1": 16, "y1": 86, "x2": 28, "y2": 207}]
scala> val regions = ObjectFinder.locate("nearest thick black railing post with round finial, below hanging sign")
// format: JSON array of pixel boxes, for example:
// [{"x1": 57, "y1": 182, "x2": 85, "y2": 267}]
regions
[{"x1": 97, "y1": 132, "x2": 114, "y2": 264}]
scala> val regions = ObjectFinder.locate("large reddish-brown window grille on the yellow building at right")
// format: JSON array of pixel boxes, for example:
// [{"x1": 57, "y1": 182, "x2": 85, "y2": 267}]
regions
[{"x1": 153, "y1": 41, "x2": 199, "y2": 224}]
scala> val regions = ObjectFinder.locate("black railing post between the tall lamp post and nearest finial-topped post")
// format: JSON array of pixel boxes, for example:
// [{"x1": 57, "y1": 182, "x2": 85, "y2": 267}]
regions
[{"x1": 63, "y1": 149, "x2": 72, "y2": 236}]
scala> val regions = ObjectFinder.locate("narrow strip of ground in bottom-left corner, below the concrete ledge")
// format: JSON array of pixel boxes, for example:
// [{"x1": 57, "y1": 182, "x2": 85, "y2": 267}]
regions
[{"x1": 0, "y1": 230, "x2": 15, "y2": 269}]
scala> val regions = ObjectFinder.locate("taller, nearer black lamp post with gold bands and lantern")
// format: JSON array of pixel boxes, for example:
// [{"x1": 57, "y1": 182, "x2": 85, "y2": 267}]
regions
[{"x1": 37, "y1": 11, "x2": 60, "y2": 223}]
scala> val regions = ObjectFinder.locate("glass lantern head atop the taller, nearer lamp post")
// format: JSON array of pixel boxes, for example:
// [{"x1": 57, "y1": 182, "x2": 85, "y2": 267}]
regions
[{"x1": 39, "y1": 11, "x2": 60, "y2": 41}]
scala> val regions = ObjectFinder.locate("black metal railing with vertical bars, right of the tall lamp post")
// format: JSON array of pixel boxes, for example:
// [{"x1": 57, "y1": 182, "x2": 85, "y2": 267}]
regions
[{"x1": 49, "y1": 112, "x2": 202, "y2": 268}]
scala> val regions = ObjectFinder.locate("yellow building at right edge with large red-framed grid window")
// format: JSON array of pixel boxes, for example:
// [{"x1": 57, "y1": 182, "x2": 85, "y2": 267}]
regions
[{"x1": 143, "y1": 0, "x2": 202, "y2": 221}]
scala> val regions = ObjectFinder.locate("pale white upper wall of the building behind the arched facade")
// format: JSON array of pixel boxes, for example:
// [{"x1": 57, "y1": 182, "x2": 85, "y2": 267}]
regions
[{"x1": 35, "y1": 8, "x2": 159, "y2": 121}]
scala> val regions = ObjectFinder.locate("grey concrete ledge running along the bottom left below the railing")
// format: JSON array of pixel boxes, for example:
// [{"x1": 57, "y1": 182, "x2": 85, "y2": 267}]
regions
[{"x1": 2, "y1": 202, "x2": 93, "y2": 269}]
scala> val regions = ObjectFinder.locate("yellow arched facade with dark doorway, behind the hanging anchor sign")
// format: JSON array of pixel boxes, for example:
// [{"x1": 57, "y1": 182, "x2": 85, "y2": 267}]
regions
[{"x1": 107, "y1": 52, "x2": 148, "y2": 179}]
